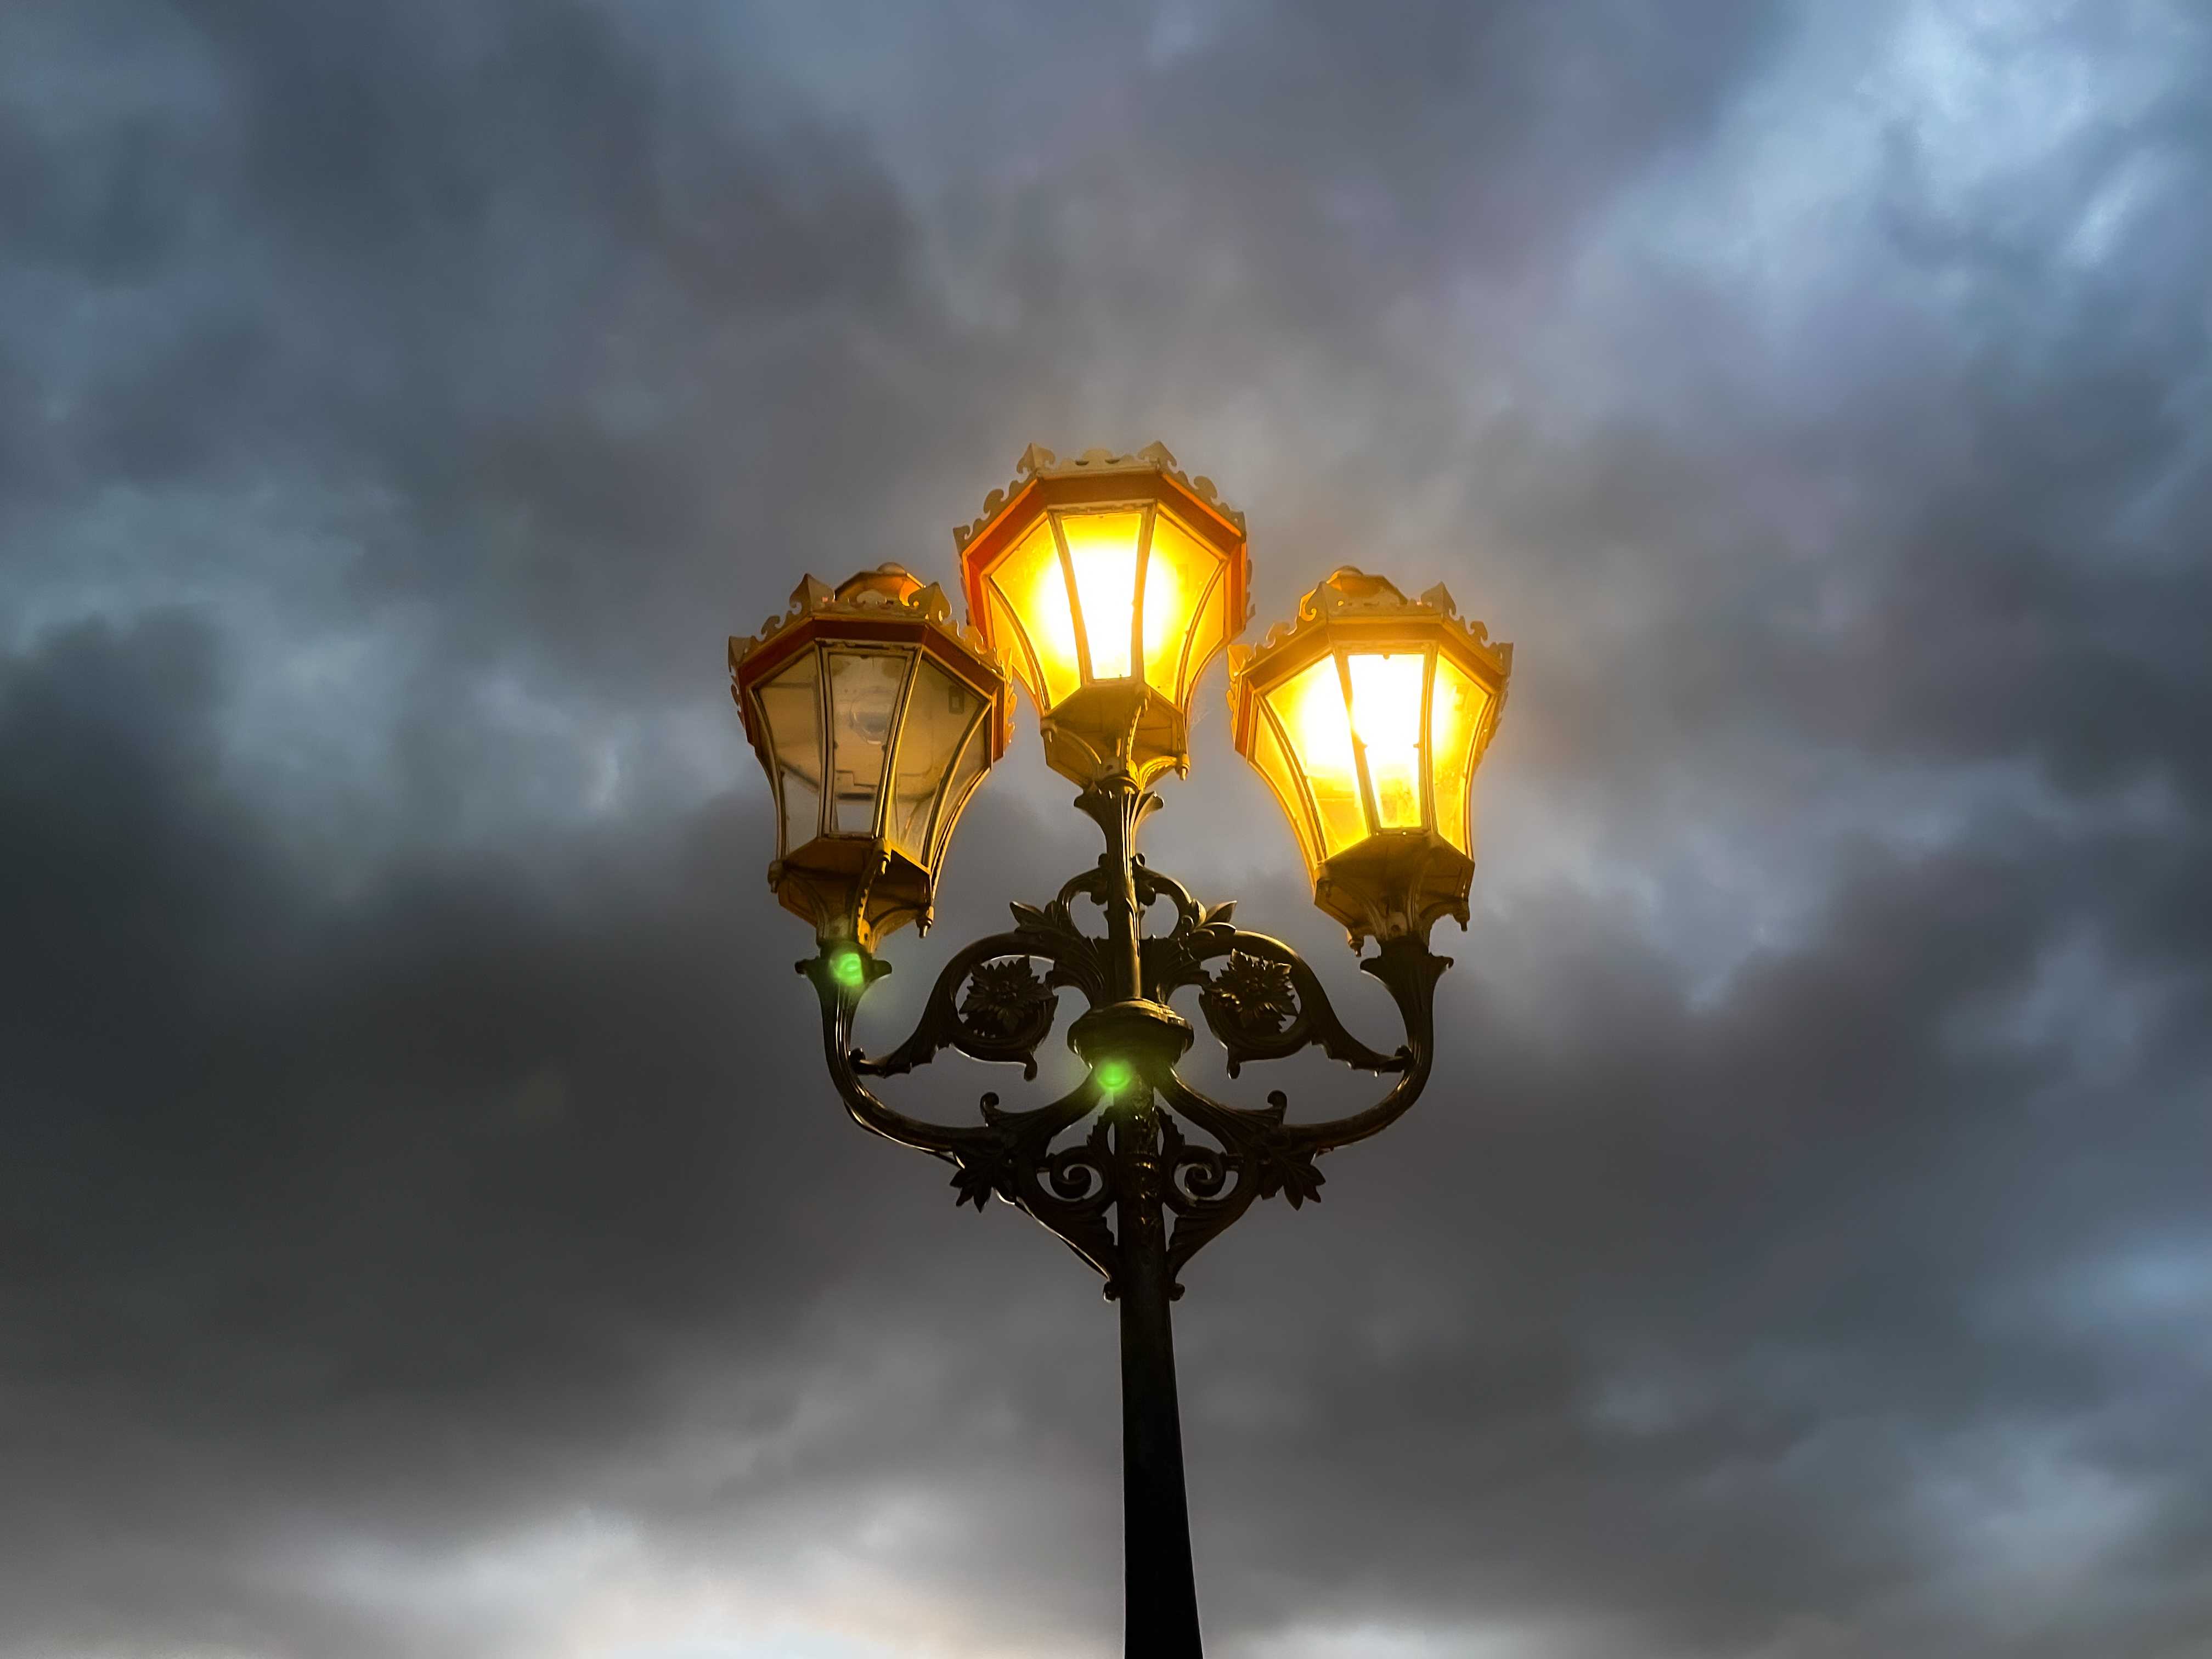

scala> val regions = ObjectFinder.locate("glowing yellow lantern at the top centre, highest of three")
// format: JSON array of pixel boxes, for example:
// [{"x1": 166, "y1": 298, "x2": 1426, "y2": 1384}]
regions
[{"x1": 953, "y1": 444, "x2": 1250, "y2": 785}]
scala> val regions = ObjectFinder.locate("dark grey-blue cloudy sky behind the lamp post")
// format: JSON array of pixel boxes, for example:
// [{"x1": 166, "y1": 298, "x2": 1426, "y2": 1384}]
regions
[{"x1": 0, "y1": 0, "x2": 2212, "y2": 1659}]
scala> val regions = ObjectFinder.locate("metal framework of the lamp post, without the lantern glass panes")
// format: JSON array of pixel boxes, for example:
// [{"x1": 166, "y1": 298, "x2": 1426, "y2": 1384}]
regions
[{"x1": 732, "y1": 444, "x2": 1511, "y2": 1659}]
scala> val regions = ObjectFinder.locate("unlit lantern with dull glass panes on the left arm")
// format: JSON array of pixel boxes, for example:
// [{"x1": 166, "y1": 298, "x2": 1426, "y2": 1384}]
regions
[{"x1": 730, "y1": 564, "x2": 1013, "y2": 951}]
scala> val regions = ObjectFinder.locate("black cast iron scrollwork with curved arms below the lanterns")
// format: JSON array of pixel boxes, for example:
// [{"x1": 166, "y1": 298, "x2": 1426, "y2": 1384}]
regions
[{"x1": 799, "y1": 778, "x2": 1449, "y2": 1296}]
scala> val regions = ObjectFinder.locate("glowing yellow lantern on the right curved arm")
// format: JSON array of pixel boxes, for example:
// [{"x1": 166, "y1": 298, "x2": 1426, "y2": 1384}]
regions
[{"x1": 1230, "y1": 566, "x2": 1513, "y2": 945}]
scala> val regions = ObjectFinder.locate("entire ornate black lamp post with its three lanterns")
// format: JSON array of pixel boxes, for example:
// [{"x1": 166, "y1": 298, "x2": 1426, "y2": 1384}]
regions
[{"x1": 730, "y1": 444, "x2": 1513, "y2": 1659}]
